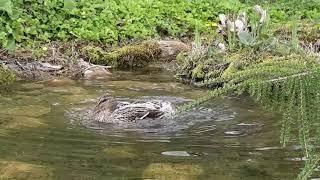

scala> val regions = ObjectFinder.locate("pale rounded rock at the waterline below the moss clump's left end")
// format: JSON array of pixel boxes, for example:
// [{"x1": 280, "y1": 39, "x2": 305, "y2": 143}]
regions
[{"x1": 83, "y1": 66, "x2": 111, "y2": 79}]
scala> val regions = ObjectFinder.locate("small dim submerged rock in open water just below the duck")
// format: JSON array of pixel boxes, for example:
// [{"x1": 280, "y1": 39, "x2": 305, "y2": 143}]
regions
[{"x1": 103, "y1": 146, "x2": 138, "y2": 159}]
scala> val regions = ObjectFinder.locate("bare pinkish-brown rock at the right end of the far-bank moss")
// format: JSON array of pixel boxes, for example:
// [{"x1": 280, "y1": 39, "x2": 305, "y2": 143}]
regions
[{"x1": 158, "y1": 41, "x2": 191, "y2": 61}]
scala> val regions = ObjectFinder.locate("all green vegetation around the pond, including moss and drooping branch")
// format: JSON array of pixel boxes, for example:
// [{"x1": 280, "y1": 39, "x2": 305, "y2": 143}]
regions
[{"x1": 0, "y1": 0, "x2": 320, "y2": 179}]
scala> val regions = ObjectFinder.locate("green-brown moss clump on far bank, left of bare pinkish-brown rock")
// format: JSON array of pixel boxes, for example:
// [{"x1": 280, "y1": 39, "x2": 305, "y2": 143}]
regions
[{"x1": 82, "y1": 41, "x2": 161, "y2": 69}]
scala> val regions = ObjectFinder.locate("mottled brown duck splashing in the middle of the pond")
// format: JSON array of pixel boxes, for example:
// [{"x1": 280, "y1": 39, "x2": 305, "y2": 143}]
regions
[{"x1": 92, "y1": 95, "x2": 174, "y2": 123}]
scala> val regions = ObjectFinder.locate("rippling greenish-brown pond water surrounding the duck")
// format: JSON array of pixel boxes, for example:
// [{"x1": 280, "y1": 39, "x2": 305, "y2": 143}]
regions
[{"x1": 0, "y1": 71, "x2": 303, "y2": 180}]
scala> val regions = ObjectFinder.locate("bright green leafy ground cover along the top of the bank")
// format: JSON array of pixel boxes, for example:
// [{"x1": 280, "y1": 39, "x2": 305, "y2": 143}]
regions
[{"x1": 0, "y1": 0, "x2": 320, "y2": 49}]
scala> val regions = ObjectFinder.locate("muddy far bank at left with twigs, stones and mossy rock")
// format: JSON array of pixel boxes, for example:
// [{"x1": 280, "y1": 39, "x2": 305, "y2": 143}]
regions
[{"x1": 0, "y1": 41, "x2": 190, "y2": 80}]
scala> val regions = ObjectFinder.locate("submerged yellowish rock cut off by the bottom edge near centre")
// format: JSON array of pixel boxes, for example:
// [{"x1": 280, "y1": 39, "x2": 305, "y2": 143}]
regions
[{"x1": 143, "y1": 163, "x2": 203, "y2": 180}]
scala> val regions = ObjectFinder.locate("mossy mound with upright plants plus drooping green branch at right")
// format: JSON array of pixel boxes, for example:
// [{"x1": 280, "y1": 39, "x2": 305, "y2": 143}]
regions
[{"x1": 177, "y1": 6, "x2": 320, "y2": 179}]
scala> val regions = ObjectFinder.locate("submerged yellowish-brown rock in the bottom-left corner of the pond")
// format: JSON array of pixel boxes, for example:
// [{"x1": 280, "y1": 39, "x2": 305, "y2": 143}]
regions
[{"x1": 0, "y1": 161, "x2": 52, "y2": 180}]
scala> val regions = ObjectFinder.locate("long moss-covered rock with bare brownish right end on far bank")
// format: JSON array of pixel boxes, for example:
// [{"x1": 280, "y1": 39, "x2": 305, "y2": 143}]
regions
[{"x1": 81, "y1": 41, "x2": 190, "y2": 69}]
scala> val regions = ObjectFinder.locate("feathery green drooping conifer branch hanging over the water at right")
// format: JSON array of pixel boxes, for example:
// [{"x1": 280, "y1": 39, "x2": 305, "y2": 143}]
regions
[{"x1": 180, "y1": 48, "x2": 320, "y2": 180}]
